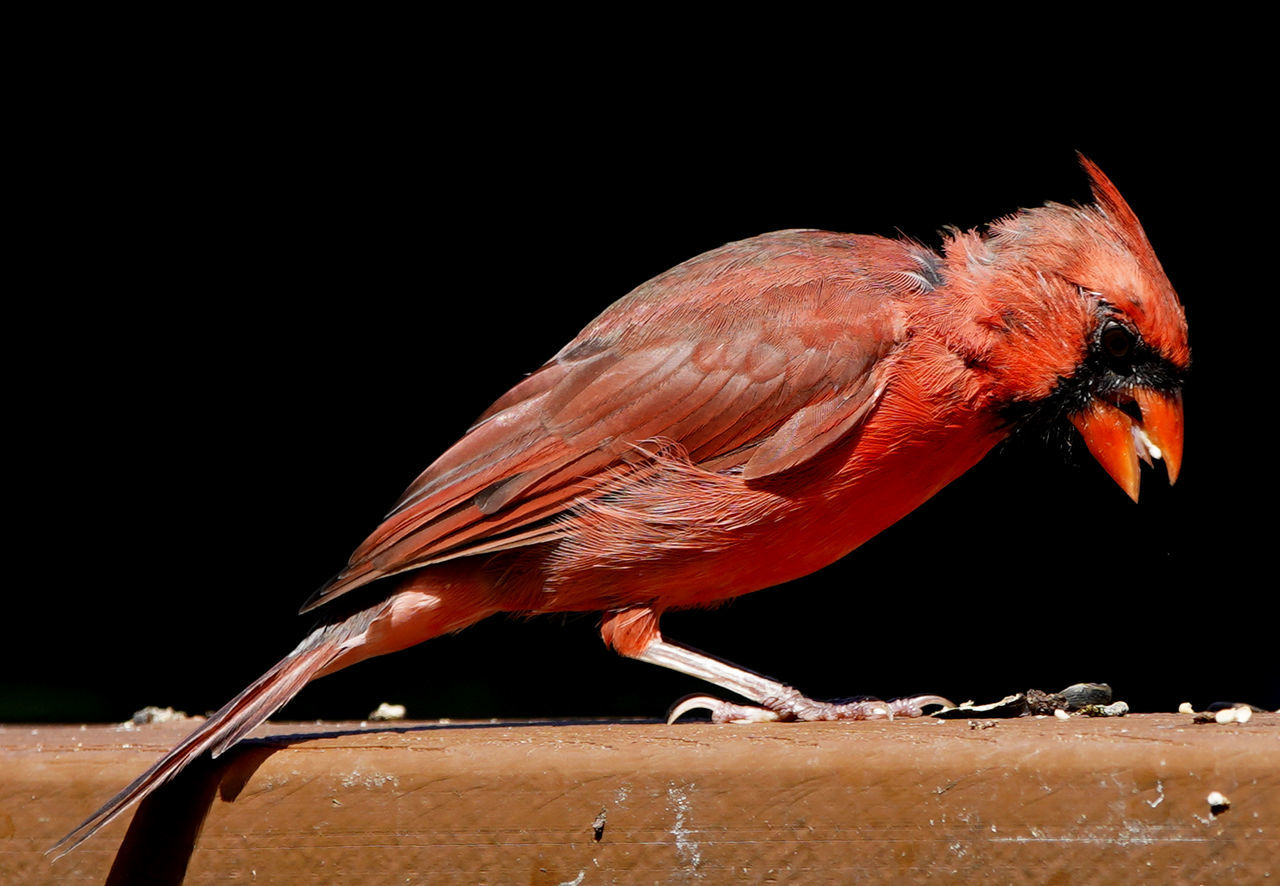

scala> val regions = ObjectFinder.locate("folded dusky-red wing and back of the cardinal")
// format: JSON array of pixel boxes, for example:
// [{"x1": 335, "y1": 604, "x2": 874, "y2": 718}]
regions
[{"x1": 303, "y1": 232, "x2": 923, "y2": 611}]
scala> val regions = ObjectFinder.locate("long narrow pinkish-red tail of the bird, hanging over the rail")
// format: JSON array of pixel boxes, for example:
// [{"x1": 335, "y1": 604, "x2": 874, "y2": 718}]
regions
[{"x1": 46, "y1": 629, "x2": 342, "y2": 859}]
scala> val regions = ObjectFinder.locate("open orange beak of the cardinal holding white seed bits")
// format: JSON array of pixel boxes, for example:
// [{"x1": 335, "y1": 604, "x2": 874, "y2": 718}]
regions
[{"x1": 1071, "y1": 388, "x2": 1183, "y2": 502}]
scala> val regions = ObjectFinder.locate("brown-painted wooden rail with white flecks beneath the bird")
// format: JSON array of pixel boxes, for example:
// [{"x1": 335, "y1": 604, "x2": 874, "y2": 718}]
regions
[{"x1": 0, "y1": 713, "x2": 1280, "y2": 886}]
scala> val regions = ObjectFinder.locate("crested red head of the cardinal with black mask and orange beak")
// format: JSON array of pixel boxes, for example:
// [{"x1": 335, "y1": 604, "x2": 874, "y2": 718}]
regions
[{"x1": 952, "y1": 156, "x2": 1190, "y2": 501}]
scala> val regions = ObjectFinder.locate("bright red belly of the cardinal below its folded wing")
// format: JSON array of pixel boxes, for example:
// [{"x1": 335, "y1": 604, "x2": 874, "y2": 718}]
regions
[{"x1": 535, "y1": 422, "x2": 1001, "y2": 612}]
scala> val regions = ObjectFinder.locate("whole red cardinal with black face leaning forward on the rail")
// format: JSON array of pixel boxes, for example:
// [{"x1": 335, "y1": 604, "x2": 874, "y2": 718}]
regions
[{"x1": 54, "y1": 159, "x2": 1190, "y2": 851}]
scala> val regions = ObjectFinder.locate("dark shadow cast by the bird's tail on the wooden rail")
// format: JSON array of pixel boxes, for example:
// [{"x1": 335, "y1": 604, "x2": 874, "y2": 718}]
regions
[{"x1": 106, "y1": 718, "x2": 662, "y2": 886}]
